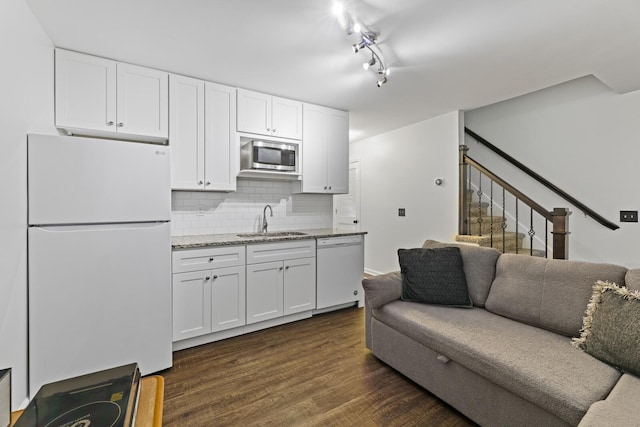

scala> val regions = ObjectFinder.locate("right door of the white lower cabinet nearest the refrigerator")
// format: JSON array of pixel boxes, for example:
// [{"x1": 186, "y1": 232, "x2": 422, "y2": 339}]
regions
[{"x1": 211, "y1": 266, "x2": 246, "y2": 332}]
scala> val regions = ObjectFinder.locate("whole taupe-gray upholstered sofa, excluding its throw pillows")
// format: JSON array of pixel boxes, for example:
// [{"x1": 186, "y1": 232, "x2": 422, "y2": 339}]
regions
[{"x1": 363, "y1": 240, "x2": 640, "y2": 427}]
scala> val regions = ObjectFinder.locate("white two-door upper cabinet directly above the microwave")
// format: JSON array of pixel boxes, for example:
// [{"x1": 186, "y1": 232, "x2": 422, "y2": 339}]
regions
[{"x1": 237, "y1": 89, "x2": 302, "y2": 139}]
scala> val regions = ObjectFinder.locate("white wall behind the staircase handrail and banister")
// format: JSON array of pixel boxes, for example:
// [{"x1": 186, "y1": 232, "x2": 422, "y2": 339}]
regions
[{"x1": 465, "y1": 77, "x2": 640, "y2": 267}]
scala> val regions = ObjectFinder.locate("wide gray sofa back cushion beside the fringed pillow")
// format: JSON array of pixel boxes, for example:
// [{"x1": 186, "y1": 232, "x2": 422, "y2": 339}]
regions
[{"x1": 486, "y1": 254, "x2": 627, "y2": 336}]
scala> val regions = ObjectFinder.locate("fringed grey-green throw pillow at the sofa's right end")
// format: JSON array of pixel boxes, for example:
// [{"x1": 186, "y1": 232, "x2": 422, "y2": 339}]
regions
[{"x1": 573, "y1": 281, "x2": 640, "y2": 375}]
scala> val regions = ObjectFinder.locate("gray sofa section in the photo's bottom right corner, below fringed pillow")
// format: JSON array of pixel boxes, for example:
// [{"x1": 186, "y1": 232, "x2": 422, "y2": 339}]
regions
[{"x1": 578, "y1": 374, "x2": 640, "y2": 427}]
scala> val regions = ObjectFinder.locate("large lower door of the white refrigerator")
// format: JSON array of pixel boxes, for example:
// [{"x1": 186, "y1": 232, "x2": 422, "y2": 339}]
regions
[{"x1": 28, "y1": 223, "x2": 172, "y2": 397}]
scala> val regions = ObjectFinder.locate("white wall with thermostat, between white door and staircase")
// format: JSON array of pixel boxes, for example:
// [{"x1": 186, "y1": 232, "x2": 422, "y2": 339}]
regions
[{"x1": 350, "y1": 111, "x2": 461, "y2": 274}]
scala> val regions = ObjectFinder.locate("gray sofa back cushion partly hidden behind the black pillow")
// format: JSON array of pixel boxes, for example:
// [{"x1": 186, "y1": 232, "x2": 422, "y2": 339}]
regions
[{"x1": 422, "y1": 240, "x2": 500, "y2": 307}]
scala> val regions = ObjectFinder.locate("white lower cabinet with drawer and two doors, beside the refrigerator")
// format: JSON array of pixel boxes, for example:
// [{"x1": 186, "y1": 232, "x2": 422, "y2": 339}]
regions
[{"x1": 173, "y1": 246, "x2": 245, "y2": 342}]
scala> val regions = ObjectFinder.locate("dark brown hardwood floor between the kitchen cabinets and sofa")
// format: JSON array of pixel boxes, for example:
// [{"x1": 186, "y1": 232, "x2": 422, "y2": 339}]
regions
[{"x1": 161, "y1": 308, "x2": 474, "y2": 426}]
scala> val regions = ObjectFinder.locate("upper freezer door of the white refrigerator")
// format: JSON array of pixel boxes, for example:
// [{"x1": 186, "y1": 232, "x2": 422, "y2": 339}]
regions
[{"x1": 28, "y1": 135, "x2": 171, "y2": 225}]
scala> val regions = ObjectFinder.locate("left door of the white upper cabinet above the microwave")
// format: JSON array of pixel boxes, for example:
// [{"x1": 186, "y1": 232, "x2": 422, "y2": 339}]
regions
[{"x1": 238, "y1": 89, "x2": 271, "y2": 135}]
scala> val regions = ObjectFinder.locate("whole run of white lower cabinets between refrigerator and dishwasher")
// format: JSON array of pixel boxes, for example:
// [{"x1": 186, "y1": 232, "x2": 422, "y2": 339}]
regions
[{"x1": 172, "y1": 239, "x2": 316, "y2": 350}]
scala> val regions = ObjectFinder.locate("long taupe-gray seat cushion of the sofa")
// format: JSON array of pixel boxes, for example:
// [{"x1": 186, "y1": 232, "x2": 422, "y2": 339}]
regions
[{"x1": 372, "y1": 301, "x2": 621, "y2": 425}]
